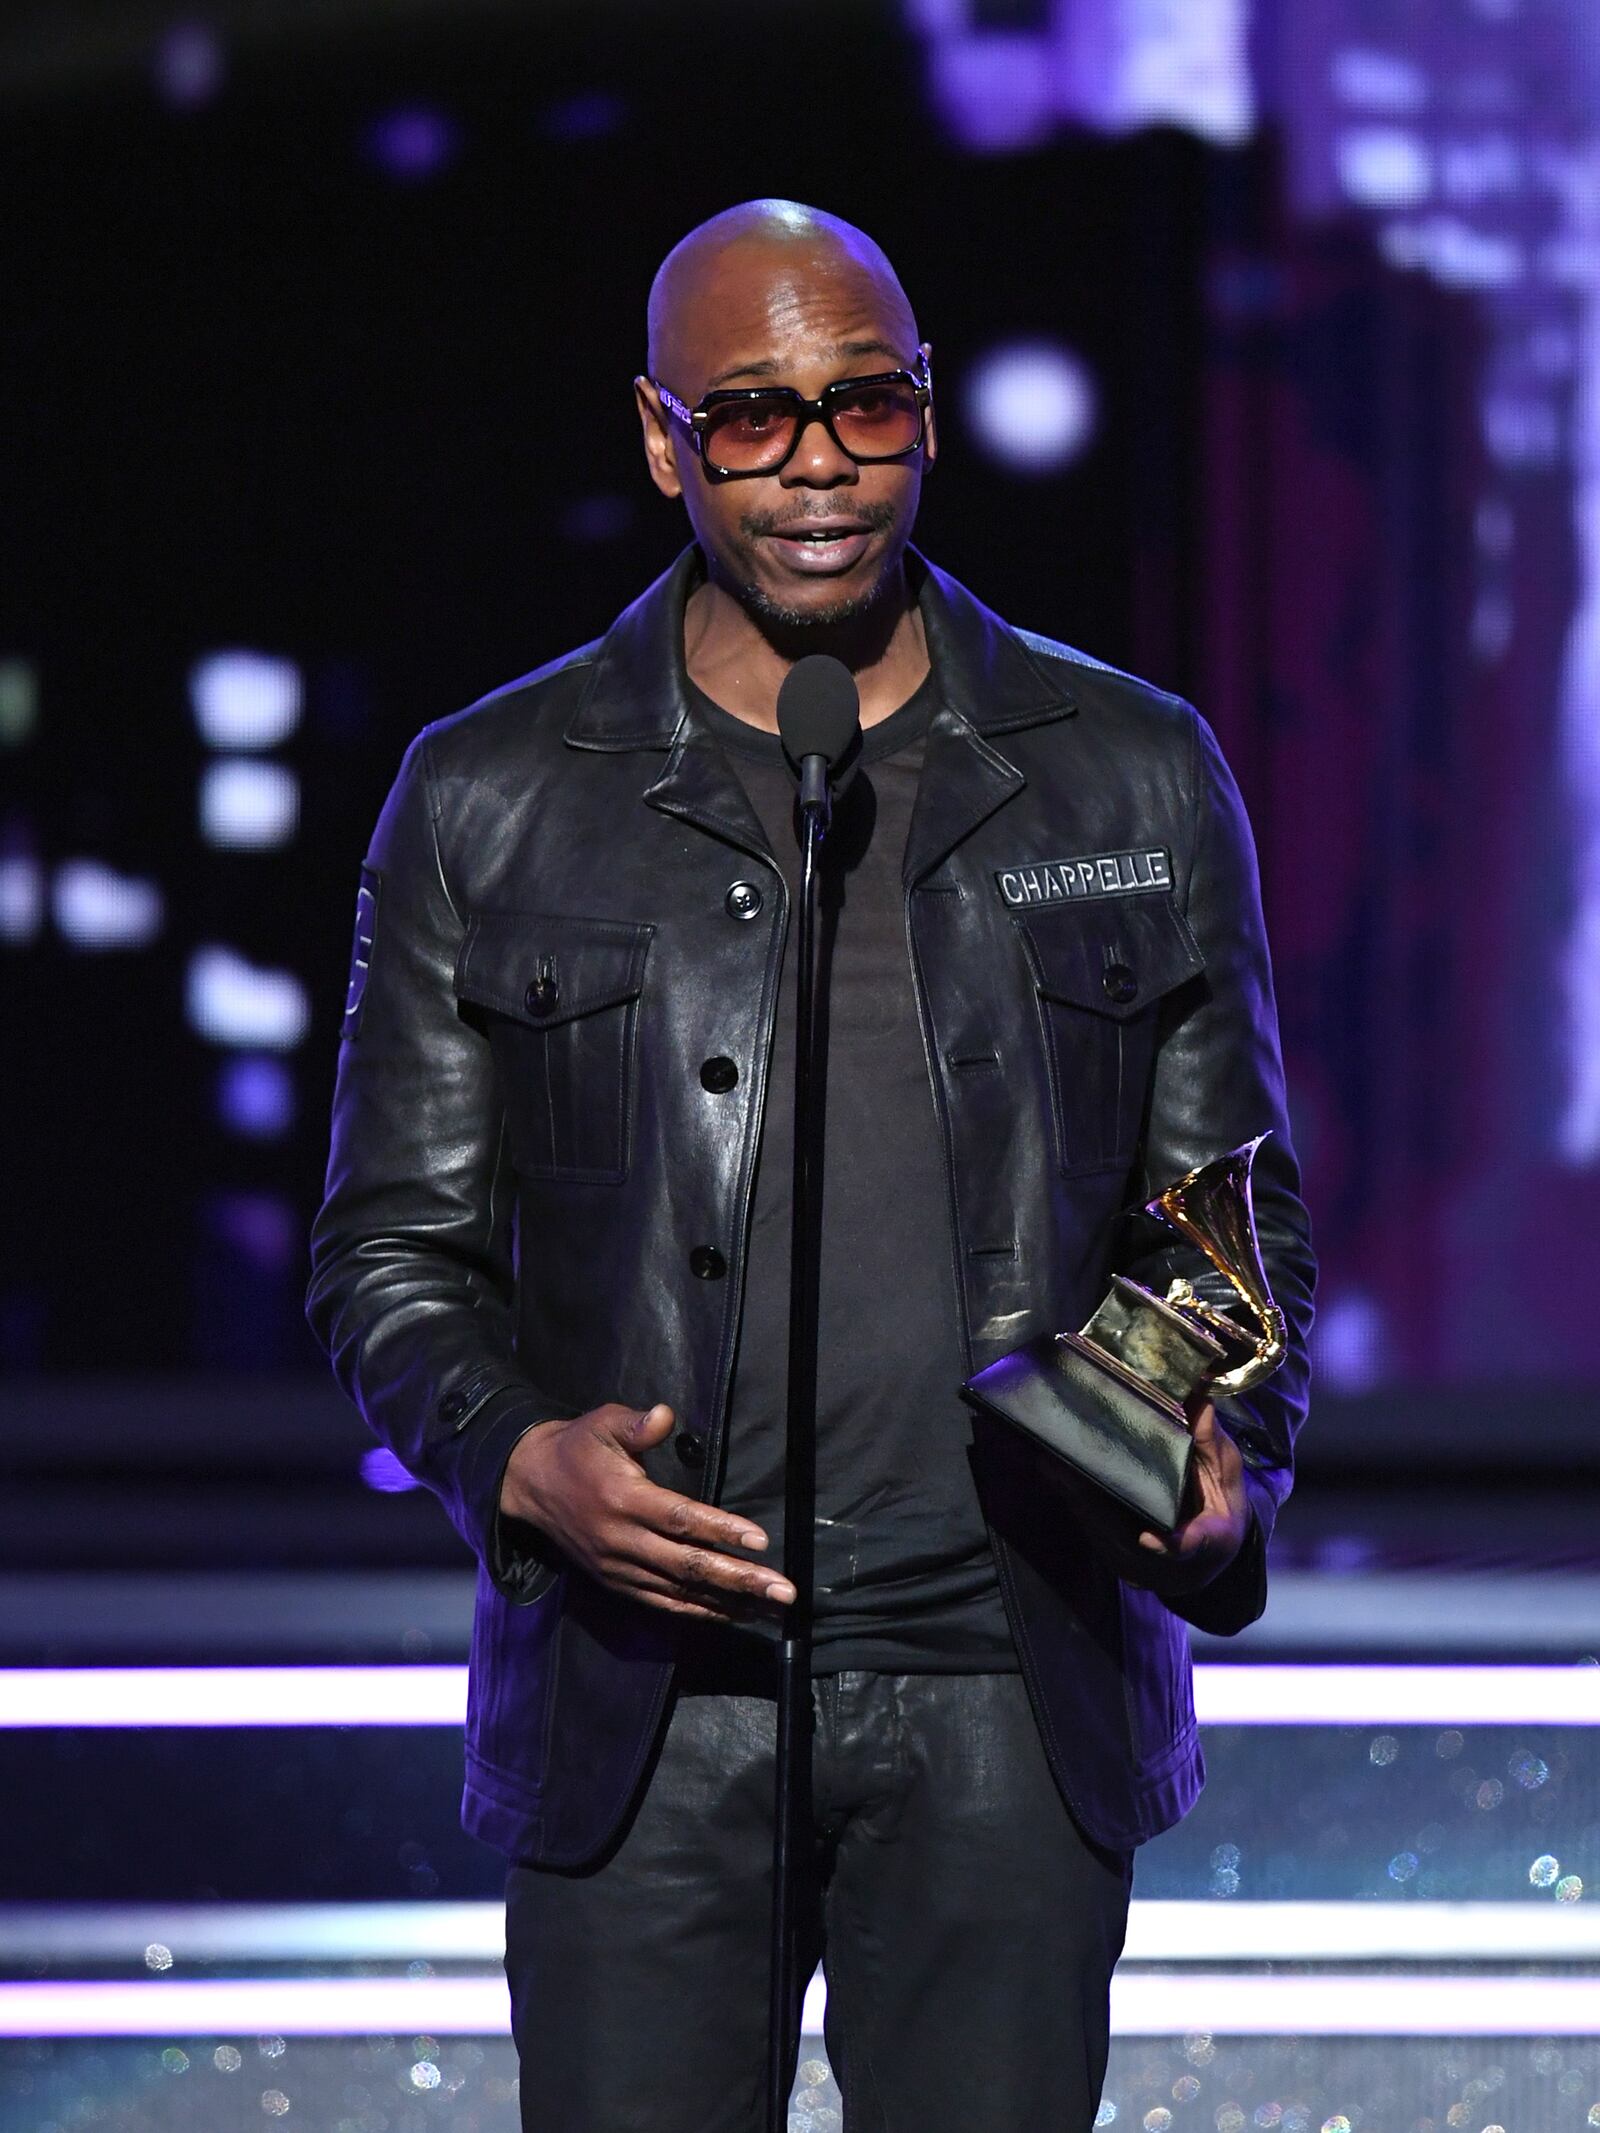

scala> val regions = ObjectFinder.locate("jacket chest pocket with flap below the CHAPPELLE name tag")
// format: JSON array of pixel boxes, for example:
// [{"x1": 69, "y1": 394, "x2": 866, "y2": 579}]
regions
[{"x1": 1028, "y1": 896, "x2": 1205, "y2": 1175}]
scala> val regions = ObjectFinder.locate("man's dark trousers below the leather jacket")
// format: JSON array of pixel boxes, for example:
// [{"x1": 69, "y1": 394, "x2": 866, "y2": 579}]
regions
[{"x1": 506, "y1": 1672, "x2": 1133, "y2": 2133}]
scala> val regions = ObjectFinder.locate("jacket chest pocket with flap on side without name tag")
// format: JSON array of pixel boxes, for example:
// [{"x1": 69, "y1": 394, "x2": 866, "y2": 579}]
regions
[{"x1": 457, "y1": 911, "x2": 655, "y2": 1184}]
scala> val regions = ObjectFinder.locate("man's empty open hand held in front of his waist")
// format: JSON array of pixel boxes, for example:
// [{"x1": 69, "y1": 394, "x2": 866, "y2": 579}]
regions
[{"x1": 499, "y1": 1401, "x2": 794, "y2": 1621}]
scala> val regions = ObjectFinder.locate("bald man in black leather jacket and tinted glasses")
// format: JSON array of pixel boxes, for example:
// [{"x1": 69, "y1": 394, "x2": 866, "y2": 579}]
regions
[{"x1": 309, "y1": 201, "x2": 1312, "y2": 2133}]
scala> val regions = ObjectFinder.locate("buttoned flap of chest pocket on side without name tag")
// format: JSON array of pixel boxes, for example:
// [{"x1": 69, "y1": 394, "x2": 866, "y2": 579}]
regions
[{"x1": 457, "y1": 911, "x2": 655, "y2": 1030}]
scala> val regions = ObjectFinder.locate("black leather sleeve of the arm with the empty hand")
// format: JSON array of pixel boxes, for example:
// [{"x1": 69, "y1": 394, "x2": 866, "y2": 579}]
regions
[{"x1": 305, "y1": 734, "x2": 572, "y2": 1602}]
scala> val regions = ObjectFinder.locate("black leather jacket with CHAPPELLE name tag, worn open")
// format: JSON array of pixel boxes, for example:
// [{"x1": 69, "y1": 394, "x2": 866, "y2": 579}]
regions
[{"x1": 307, "y1": 548, "x2": 1312, "y2": 1864}]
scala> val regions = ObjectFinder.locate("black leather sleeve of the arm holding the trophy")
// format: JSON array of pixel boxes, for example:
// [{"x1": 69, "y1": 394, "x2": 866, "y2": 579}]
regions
[{"x1": 1120, "y1": 710, "x2": 1316, "y2": 1636}]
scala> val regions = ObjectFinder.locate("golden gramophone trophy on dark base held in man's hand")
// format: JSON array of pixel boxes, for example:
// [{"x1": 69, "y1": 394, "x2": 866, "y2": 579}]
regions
[{"x1": 962, "y1": 1133, "x2": 1286, "y2": 1534}]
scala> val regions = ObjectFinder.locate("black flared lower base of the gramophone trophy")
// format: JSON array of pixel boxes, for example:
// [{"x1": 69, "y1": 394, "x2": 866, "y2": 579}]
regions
[{"x1": 962, "y1": 1333, "x2": 1195, "y2": 1534}]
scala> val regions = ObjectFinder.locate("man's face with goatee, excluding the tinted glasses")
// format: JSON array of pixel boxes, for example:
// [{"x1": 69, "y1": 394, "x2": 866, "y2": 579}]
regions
[{"x1": 638, "y1": 245, "x2": 934, "y2": 629}]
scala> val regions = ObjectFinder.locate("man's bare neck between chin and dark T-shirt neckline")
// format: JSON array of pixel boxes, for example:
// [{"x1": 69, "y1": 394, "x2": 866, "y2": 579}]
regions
[{"x1": 683, "y1": 567, "x2": 928, "y2": 734}]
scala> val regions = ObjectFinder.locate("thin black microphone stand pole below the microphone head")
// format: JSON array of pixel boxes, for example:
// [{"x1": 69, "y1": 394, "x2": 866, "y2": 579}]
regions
[{"x1": 766, "y1": 755, "x2": 832, "y2": 2133}]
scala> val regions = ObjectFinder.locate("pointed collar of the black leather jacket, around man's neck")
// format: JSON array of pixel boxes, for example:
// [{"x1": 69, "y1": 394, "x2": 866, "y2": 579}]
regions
[{"x1": 567, "y1": 546, "x2": 1077, "y2": 751}]
